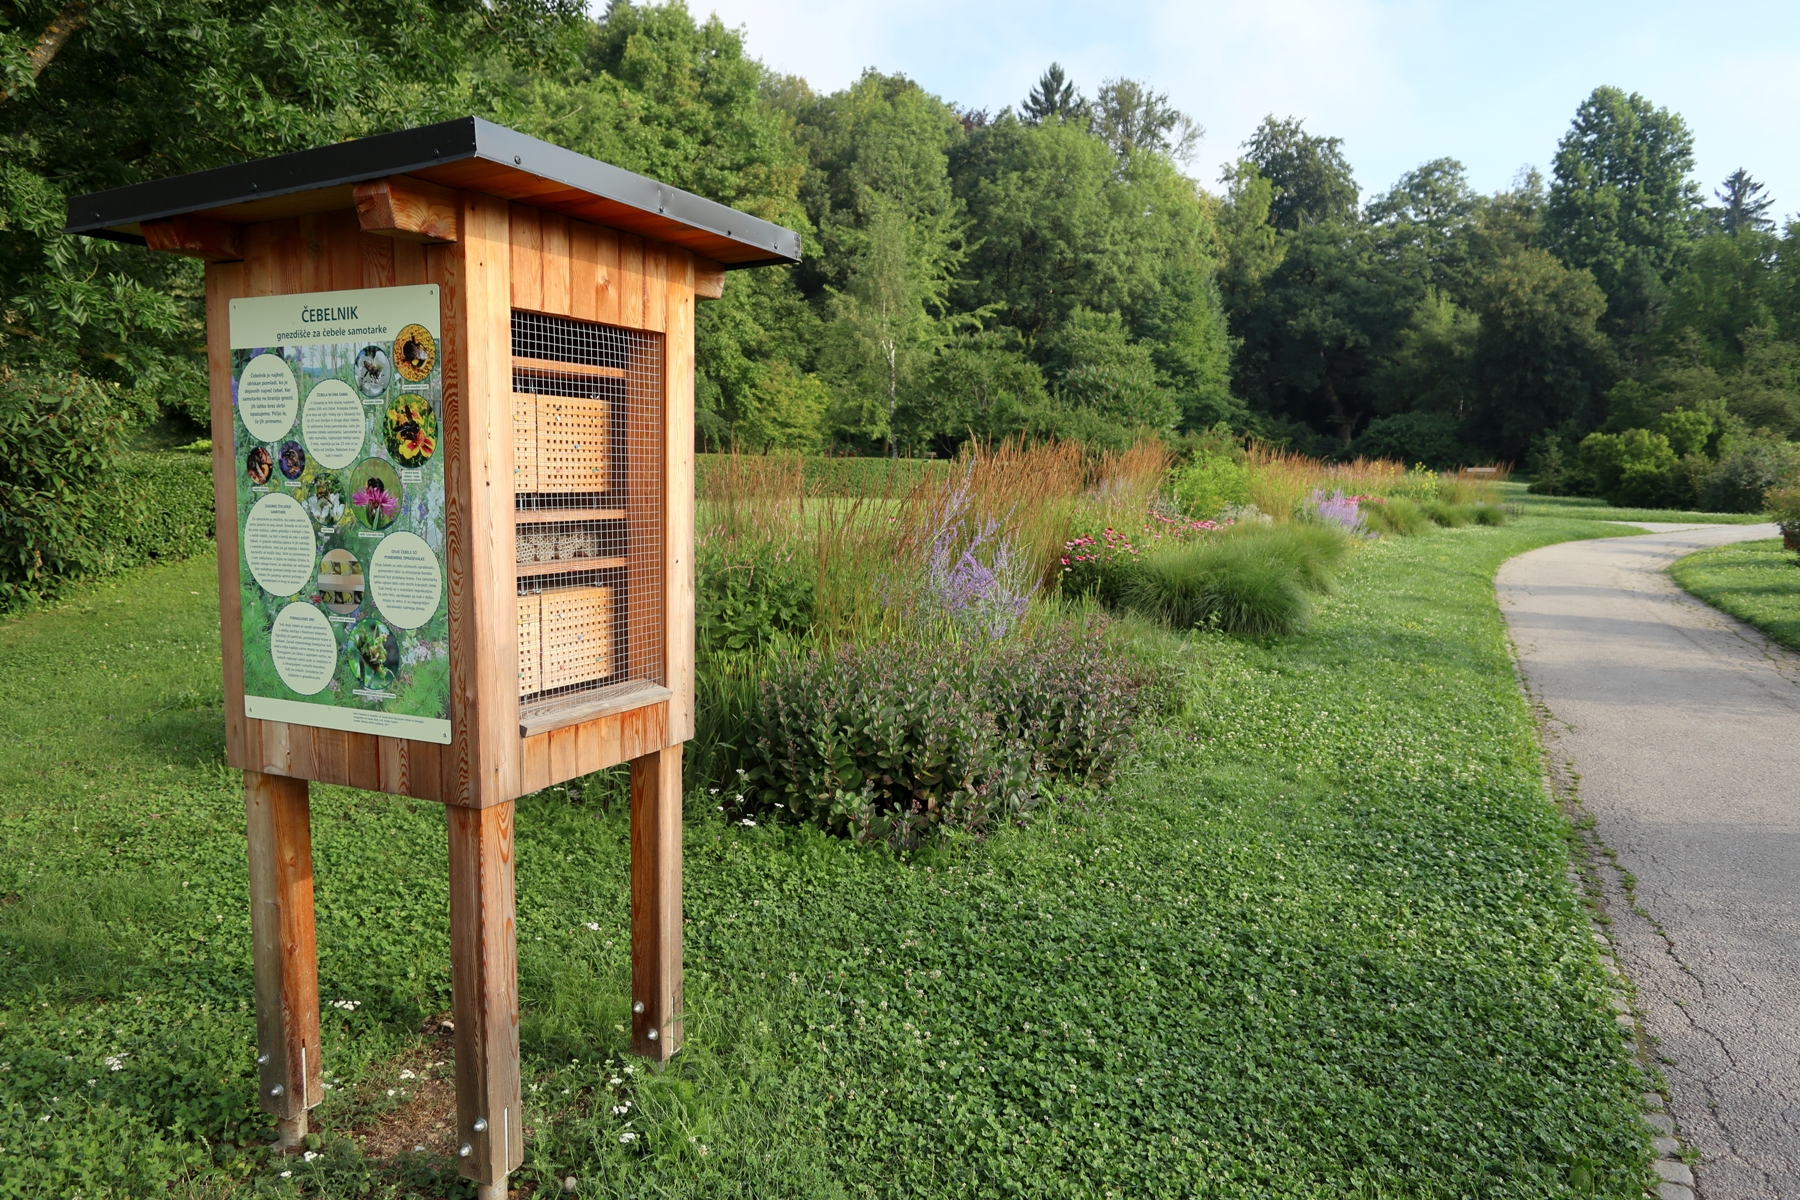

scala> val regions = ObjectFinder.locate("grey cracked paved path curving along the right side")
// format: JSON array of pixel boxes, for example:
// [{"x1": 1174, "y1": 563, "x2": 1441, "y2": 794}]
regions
[{"x1": 1498, "y1": 525, "x2": 1800, "y2": 1200}]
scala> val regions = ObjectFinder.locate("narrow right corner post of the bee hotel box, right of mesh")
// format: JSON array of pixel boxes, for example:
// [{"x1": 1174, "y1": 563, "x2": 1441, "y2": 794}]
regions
[{"x1": 662, "y1": 250, "x2": 695, "y2": 741}]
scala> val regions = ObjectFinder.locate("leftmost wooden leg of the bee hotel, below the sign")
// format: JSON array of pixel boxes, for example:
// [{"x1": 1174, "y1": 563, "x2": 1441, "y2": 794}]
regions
[{"x1": 243, "y1": 770, "x2": 324, "y2": 1150}]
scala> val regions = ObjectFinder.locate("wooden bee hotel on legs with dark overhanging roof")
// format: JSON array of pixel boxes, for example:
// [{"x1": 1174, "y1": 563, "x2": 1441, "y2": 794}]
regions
[{"x1": 68, "y1": 119, "x2": 799, "y2": 1196}]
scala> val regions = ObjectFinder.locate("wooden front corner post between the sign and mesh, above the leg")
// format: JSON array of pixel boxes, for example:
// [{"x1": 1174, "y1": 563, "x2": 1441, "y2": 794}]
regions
[{"x1": 444, "y1": 193, "x2": 522, "y2": 808}]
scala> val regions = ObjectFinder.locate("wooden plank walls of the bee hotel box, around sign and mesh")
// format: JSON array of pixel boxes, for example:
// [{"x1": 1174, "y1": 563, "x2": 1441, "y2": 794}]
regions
[{"x1": 207, "y1": 193, "x2": 691, "y2": 808}]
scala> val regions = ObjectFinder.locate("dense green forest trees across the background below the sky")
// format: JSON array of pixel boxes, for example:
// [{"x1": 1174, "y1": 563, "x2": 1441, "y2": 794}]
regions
[{"x1": 0, "y1": 0, "x2": 1800, "y2": 500}]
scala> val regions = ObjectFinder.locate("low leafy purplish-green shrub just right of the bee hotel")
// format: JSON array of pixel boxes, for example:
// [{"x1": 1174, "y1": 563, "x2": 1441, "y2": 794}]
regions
[{"x1": 722, "y1": 628, "x2": 1152, "y2": 847}]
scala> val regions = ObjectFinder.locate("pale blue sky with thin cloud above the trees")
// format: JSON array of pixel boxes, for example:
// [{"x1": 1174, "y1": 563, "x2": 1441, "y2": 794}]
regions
[{"x1": 689, "y1": 0, "x2": 1800, "y2": 214}]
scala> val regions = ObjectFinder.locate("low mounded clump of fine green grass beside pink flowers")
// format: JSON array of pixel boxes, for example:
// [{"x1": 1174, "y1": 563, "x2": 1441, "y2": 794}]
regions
[{"x1": 1120, "y1": 524, "x2": 1345, "y2": 637}]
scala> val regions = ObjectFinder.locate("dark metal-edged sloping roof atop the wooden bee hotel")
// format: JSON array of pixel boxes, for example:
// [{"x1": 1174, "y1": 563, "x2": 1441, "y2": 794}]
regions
[{"x1": 65, "y1": 117, "x2": 801, "y2": 268}]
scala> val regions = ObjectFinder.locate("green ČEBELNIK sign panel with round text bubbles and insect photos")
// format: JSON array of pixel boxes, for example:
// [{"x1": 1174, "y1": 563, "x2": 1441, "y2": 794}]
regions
[{"x1": 230, "y1": 284, "x2": 450, "y2": 743}]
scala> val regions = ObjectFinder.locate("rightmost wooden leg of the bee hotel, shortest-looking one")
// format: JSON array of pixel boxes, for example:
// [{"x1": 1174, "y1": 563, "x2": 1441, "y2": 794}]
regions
[{"x1": 632, "y1": 747, "x2": 682, "y2": 1061}]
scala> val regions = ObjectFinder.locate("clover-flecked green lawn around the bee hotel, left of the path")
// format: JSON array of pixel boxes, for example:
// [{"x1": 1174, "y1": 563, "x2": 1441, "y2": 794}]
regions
[{"x1": 0, "y1": 518, "x2": 1649, "y2": 1200}]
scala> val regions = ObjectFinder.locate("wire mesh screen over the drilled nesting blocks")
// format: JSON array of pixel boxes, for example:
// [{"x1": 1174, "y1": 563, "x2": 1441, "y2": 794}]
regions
[{"x1": 513, "y1": 311, "x2": 664, "y2": 711}]
